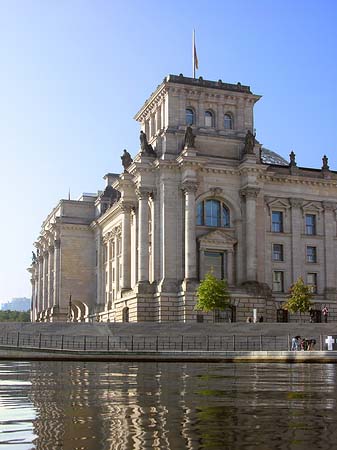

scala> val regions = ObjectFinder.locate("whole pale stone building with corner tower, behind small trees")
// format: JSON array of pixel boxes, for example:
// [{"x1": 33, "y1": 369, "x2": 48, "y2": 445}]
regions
[{"x1": 29, "y1": 75, "x2": 337, "y2": 322}]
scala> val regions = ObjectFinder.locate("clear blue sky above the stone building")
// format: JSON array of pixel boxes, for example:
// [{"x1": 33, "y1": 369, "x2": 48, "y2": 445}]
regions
[{"x1": 0, "y1": 0, "x2": 337, "y2": 301}]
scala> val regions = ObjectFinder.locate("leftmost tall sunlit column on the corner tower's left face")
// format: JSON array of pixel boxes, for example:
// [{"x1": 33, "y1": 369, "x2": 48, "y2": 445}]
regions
[{"x1": 121, "y1": 203, "x2": 131, "y2": 290}]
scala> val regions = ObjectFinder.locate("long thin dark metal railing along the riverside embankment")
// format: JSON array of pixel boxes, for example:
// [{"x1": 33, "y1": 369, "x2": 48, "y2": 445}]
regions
[{"x1": 0, "y1": 332, "x2": 323, "y2": 352}]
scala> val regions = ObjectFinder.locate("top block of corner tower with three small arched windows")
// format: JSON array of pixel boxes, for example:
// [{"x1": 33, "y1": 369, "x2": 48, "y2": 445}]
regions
[{"x1": 135, "y1": 74, "x2": 261, "y2": 160}]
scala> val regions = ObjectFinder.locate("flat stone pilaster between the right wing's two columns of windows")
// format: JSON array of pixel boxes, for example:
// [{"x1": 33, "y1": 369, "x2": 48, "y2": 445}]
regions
[{"x1": 290, "y1": 198, "x2": 303, "y2": 284}]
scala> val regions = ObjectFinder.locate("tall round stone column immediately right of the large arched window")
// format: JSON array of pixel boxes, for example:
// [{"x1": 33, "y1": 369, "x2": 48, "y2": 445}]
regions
[{"x1": 241, "y1": 187, "x2": 259, "y2": 281}]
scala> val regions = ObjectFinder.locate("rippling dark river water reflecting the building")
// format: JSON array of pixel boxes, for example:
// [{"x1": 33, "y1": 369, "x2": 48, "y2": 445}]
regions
[{"x1": 0, "y1": 361, "x2": 337, "y2": 450}]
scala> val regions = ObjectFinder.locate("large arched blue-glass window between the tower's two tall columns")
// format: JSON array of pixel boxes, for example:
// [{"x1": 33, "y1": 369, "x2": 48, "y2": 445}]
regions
[{"x1": 197, "y1": 200, "x2": 230, "y2": 227}]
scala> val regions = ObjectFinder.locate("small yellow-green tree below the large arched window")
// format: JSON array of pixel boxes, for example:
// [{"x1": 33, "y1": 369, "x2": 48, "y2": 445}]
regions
[{"x1": 195, "y1": 273, "x2": 230, "y2": 312}]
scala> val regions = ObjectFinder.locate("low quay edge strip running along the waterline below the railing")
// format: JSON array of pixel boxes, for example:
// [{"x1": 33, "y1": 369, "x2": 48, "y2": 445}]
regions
[{"x1": 0, "y1": 346, "x2": 337, "y2": 363}]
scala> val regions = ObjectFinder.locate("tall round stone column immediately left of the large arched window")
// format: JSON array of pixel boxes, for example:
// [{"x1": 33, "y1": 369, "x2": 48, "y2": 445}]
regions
[{"x1": 183, "y1": 182, "x2": 197, "y2": 280}]
